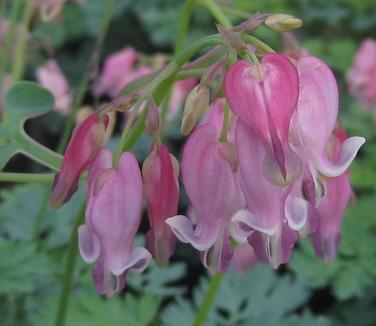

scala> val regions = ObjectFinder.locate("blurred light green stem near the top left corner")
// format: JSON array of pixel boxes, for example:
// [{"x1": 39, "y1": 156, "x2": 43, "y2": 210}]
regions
[{"x1": 12, "y1": 1, "x2": 33, "y2": 83}]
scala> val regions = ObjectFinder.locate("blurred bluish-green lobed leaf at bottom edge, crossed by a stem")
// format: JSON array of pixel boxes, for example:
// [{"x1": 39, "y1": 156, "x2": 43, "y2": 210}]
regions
[{"x1": 162, "y1": 264, "x2": 328, "y2": 326}]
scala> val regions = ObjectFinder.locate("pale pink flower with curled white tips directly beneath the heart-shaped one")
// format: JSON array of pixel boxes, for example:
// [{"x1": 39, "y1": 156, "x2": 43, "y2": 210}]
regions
[{"x1": 232, "y1": 120, "x2": 298, "y2": 268}]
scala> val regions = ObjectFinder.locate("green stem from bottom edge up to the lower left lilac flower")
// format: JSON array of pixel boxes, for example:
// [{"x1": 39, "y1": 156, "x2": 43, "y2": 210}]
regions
[{"x1": 55, "y1": 203, "x2": 85, "y2": 326}]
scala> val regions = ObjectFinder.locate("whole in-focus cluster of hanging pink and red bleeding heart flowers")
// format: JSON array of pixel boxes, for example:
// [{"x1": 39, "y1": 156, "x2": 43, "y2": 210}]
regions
[{"x1": 51, "y1": 21, "x2": 365, "y2": 296}]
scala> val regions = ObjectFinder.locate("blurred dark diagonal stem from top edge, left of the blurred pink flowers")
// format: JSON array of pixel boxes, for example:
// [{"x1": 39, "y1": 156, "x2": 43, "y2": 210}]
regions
[{"x1": 58, "y1": 0, "x2": 116, "y2": 153}]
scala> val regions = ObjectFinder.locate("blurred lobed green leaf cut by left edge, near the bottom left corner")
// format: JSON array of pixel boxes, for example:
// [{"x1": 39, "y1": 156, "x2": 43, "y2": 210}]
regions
[{"x1": 0, "y1": 239, "x2": 51, "y2": 294}]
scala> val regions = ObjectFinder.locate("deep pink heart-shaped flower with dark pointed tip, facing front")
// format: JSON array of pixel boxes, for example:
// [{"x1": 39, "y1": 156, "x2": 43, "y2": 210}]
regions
[{"x1": 224, "y1": 54, "x2": 301, "y2": 185}]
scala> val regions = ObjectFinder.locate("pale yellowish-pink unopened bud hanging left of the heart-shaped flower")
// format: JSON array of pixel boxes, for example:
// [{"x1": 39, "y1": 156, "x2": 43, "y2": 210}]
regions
[{"x1": 180, "y1": 85, "x2": 210, "y2": 135}]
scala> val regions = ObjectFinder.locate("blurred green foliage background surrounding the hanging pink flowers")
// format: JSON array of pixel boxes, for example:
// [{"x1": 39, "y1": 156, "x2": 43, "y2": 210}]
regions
[{"x1": 0, "y1": 0, "x2": 376, "y2": 326}]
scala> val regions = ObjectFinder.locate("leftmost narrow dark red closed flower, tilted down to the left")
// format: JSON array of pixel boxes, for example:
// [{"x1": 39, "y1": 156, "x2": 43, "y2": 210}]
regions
[{"x1": 50, "y1": 113, "x2": 109, "y2": 208}]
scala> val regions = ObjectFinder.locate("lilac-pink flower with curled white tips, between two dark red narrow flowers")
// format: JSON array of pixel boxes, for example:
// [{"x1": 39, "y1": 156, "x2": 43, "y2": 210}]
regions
[{"x1": 78, "y1": 149, "x2": 151, "y2": 297}]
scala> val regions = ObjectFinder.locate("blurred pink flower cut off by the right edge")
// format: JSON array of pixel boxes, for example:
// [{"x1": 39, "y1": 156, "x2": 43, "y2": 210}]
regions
[{"x1": 347, "y1": 39, "x2": 376, "y2": 107}]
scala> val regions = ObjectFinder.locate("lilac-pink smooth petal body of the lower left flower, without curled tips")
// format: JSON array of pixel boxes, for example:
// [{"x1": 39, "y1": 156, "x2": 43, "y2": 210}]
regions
[{"x1": 90, "y1": 152, "x2": 142, "y2": 273}]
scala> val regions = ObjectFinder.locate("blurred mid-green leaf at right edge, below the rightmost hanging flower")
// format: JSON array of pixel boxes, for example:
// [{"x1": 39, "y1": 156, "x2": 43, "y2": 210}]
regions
[{"x1": 289, "y1": 196, "x2": 376, "y2": 300}]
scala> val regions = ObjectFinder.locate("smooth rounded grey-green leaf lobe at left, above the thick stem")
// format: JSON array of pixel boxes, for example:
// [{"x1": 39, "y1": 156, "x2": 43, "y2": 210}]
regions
[{"x1": 5, "y1": 81, "x2": 54, "y2": 131}]
